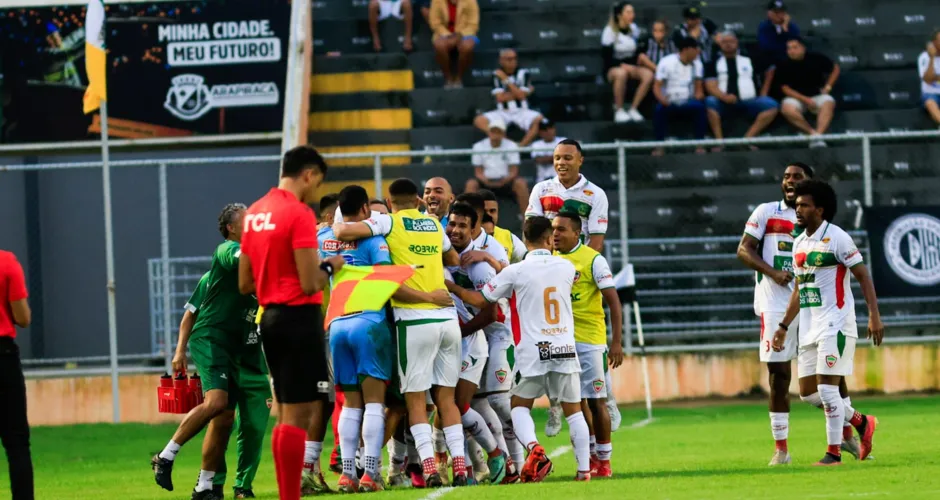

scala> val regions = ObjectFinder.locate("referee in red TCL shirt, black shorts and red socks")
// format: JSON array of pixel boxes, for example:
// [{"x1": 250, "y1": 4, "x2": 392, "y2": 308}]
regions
[{"x1": 238, "y1": 146, "x2": 344, "y2": 500}]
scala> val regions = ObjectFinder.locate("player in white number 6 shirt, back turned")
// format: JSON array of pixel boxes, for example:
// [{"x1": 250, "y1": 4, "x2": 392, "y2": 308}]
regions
[{"x1": 452, "y1": 216, "x2": 591, "y2": 482}]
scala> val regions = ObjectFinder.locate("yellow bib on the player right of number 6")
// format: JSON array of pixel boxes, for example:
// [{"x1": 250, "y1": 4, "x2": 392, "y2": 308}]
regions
[{"x1": 555, "y1": 243, "x2": 607, "y2": 345}]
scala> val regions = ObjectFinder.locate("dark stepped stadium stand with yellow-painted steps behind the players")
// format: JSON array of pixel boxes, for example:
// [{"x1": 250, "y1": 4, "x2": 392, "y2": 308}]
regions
[{"x1": 311, "y1": 0, "x2": 940, "y2": 344}]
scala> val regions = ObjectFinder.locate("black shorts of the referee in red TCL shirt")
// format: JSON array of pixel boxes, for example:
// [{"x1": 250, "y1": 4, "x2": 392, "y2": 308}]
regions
[{"x1": 261, "y1": 304, "x2": 330, "y2": 404}]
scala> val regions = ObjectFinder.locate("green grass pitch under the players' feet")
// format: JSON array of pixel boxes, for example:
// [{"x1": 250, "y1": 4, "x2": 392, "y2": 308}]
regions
[{"x1": 0, "y1": 396, "x2": 940, "y2": 500}]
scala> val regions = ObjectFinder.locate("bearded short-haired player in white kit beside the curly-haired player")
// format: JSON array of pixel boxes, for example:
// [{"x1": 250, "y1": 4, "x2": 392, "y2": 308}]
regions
[{"x1": 738, "y1": 162, "x2": 813, "y2": 465}]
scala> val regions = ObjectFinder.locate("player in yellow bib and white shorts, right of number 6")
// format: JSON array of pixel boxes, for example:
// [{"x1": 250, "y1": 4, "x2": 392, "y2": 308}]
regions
[{"x1": 552, "y1": 212, "x2": 623, "y2": 477}]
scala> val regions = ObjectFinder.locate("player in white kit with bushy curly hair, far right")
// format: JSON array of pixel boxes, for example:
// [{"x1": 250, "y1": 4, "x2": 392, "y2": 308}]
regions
[{"x1": 773, "y1": 180, "x2": 884, "y2": 465}]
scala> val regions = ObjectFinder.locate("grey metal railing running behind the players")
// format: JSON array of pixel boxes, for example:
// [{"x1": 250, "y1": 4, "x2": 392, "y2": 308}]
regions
[{"x1": 11, "y1": 130, "x2": 940, "y2": 376}]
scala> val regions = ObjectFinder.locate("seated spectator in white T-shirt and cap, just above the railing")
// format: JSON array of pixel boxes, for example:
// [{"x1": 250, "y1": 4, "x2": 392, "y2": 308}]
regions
[{"x1": 464, "y1": 118, "x2": 529, "y2": 218}]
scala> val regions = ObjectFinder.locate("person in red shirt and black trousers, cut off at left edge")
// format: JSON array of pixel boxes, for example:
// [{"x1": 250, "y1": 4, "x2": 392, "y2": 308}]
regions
[{"x1": 0, "y1": 250, "x2": 33, "y2": 500}]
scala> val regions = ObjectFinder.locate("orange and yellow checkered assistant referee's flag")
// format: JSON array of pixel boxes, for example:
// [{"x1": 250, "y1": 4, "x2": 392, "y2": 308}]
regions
[{"x1": 324, "y1": 266, "x2": 415, "y2": 328}]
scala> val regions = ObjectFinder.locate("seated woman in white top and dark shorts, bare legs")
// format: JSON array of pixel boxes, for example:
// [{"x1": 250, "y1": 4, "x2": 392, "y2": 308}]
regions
[{"x1": 601, "y1": 2, "x2": 653, "y2": 123}]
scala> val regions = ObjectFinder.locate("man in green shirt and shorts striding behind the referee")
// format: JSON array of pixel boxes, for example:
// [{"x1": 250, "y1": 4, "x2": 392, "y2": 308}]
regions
[{"x1": 151, "y1": 203, "x2": 266, "y2": 500}]
